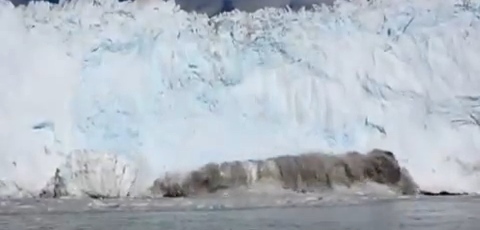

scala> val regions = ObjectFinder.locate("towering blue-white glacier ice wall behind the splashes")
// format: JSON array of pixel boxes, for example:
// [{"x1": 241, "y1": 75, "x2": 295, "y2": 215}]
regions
[{"x1": 0, "y1": 0, "x2": 480, "y2": 197}]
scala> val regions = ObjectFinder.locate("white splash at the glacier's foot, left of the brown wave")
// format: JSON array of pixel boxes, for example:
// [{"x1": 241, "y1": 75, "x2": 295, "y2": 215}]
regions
[{"x1": 0, "y1": 150, "x2": 145, "y2": 198}]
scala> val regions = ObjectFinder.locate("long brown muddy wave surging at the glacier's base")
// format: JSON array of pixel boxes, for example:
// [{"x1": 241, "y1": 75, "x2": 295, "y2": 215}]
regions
[{"x1": 150, "y1": 149, "x2": 419, "y2": 197}]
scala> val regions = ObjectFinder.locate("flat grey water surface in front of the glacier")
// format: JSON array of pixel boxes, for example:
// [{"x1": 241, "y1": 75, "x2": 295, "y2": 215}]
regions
[{"x1": 0, "y1": 197, "x2": 480, "y2": 230}]
